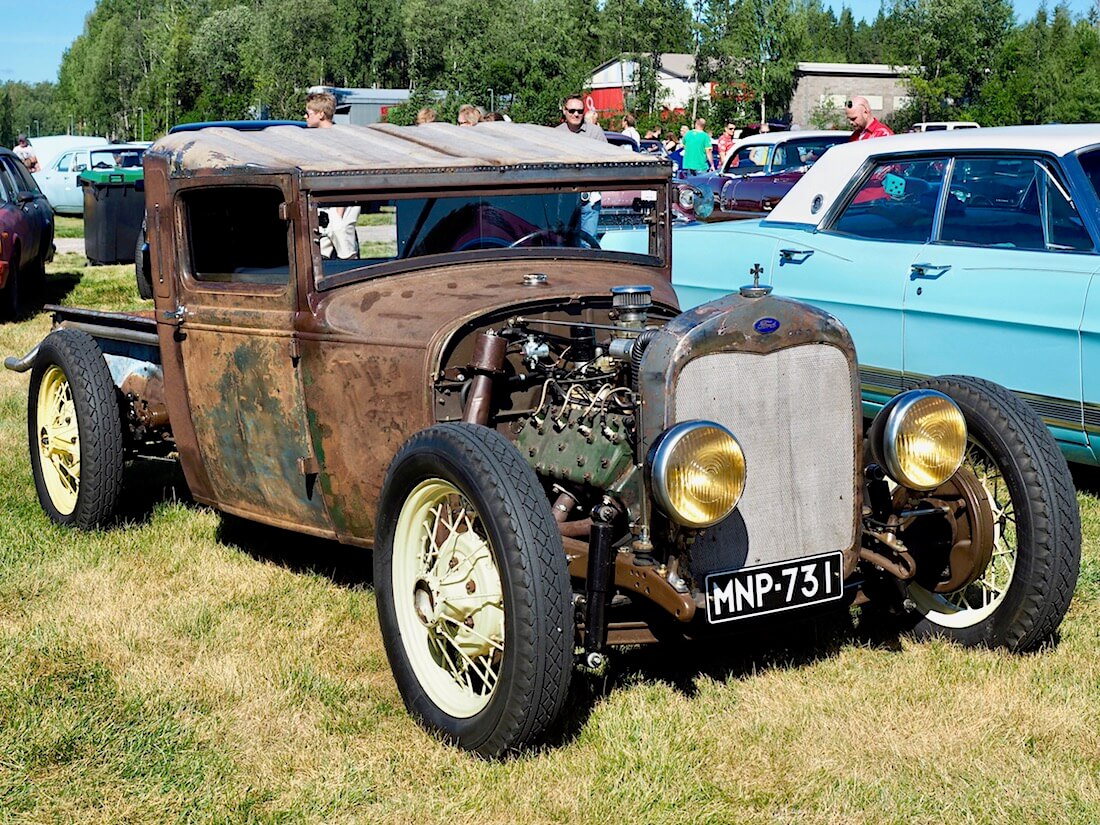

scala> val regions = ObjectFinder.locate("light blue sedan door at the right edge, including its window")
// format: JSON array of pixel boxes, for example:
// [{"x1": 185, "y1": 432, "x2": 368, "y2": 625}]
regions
[{"x1": 904, "y1": 153, "x2": 1100, "y2": 455}]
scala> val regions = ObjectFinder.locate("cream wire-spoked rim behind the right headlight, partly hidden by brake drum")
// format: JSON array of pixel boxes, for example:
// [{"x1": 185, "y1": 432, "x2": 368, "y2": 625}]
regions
[{"x1": 910, "y1": 441, "x2": 1019, "y2": 628}]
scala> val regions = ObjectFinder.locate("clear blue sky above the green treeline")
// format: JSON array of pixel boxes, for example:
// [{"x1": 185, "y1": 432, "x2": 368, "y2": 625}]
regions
[{"x1": 0, "y1": 0, "x2": 1092, "y2": 83}]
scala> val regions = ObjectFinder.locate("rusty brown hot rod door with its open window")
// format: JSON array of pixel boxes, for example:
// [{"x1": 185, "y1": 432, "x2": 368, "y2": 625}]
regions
[{"x1": 169, "y1": 177, "x2": 329, "y2": 531}]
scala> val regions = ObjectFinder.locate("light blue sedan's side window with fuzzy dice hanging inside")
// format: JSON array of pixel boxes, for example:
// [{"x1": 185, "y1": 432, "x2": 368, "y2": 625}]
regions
[{"x1": 831, "y1": 157, "x2": 947, "y2": 243}]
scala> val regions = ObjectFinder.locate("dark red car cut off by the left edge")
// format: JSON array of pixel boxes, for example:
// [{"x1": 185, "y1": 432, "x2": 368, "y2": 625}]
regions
[{"x1": 0, "y1": 149, "x2": 54, "y2": 320}]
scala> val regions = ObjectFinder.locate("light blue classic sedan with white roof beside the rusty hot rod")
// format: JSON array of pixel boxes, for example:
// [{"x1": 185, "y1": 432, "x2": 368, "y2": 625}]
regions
[{"x1": 602, "y1": 124, "x2": 1100, "y2": 464}]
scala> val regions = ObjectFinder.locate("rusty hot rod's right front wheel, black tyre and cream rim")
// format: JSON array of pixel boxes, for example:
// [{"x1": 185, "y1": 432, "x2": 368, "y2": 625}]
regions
[{"x1": 908, "y1": 376, "x2": 1081, "y2": 650}]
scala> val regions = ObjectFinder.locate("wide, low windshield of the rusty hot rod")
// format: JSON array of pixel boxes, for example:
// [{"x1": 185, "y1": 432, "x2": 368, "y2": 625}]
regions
[{"x1": 315, "y1": 189, "x2": 664, "y2": 288}]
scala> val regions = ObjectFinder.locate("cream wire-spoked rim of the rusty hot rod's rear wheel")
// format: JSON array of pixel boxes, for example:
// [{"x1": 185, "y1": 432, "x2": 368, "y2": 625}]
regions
[{"x1": 36, "y1": 365, "x2": 80, "y2": 516}]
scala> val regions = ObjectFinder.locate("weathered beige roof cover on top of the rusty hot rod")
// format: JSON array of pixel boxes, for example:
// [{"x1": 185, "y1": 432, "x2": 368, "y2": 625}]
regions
[{"x1": 147, "y1": 122, "x2": 671, "y2": 180}]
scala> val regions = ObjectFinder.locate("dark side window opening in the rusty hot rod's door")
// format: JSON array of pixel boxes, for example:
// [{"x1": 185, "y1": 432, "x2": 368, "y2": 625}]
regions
[{"x1": 182, "y1": 186, "x2": 290, "y2": 286}]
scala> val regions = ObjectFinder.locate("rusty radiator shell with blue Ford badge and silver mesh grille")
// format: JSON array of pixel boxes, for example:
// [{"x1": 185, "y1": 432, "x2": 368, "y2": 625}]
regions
[{"x1": 639, "y1": 294, "x2": 862, "y2": 576}]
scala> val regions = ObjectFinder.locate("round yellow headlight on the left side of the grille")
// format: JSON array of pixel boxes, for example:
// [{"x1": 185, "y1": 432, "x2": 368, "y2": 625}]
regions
[{"x1": 649, "y1": 421, "x2": 745, "y2": 528}]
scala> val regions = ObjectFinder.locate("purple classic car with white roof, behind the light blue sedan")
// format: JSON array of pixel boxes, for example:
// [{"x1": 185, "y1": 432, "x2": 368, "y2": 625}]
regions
[{"x1": 673, "y1": 131, "x2": 849, "y2": 220}]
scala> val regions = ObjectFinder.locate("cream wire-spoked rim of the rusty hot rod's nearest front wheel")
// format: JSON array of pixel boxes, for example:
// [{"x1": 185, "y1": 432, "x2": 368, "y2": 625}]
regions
[{"x1": 393, "y1": 479, "x2": 505, "y2": 718}]
